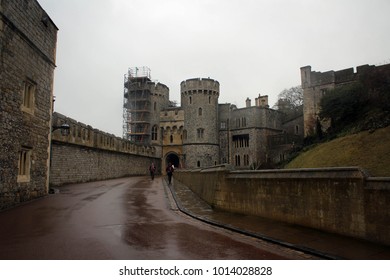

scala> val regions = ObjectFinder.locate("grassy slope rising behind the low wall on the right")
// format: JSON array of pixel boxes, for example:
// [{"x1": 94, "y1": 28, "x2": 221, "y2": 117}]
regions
[{"x1": 285, "y1": 126, "x2": 390, "y2": 177}]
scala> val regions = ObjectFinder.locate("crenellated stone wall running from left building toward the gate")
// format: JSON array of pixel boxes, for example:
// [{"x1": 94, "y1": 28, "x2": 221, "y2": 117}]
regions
[{"x1": 50, "y1": 113, "x2": 161, "y2": 187}]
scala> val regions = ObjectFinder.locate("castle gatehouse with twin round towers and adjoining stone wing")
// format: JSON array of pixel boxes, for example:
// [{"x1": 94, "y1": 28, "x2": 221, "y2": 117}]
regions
[{"x1": 123, "y1": 68, "x2": 303, "y2": 171}]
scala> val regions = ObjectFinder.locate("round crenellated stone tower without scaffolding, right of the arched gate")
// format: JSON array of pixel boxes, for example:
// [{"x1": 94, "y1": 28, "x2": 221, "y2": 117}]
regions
[{"x1": 180, "y1": 78, "x2": 219, "y2": 168}]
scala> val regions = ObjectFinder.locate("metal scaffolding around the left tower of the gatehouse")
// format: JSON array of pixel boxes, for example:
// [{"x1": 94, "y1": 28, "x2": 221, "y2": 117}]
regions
[{"x1": 123, "y1": 67, "x2": 153, "y2": 145}]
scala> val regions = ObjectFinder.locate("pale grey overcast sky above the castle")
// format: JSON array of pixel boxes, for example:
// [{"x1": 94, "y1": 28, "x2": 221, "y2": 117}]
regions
[{"x1": 38, "y1": 0, "x2": 390, "y2": 136}]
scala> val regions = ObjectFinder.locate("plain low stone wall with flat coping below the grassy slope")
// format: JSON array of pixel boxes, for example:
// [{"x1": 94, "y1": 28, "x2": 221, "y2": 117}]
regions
[{"x1": 174, "y1": 166, "x2": 390, "y2": 245}]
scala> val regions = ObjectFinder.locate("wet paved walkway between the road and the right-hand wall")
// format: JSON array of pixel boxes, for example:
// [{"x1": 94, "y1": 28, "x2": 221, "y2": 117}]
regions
[{"x1": 163, "y1": 180, "x2": 390, "y2": 260}]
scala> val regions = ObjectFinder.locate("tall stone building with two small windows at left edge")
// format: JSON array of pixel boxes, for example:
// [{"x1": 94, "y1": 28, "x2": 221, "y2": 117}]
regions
[{"x1": 0, "y1": 0, "x2": 58, "y2": 210}]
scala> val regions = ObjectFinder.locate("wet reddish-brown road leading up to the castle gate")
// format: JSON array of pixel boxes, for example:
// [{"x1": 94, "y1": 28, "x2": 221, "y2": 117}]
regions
[{"x1": 0, "y1": 177, "x2": 310, "y2": 260}]
